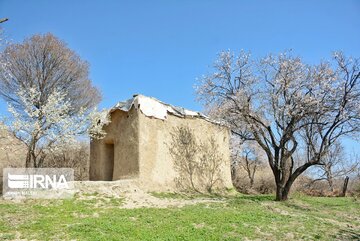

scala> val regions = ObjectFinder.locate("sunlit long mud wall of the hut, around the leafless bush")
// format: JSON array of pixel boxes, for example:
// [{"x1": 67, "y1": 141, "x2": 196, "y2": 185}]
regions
[{"x1": 139, "y1": 113, "x2": 232, "y2": 191}]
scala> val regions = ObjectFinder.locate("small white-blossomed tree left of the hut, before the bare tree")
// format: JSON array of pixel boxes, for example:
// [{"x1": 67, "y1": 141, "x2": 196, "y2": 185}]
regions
[{"x1": 5, "y1": 88, "x2": 109, "y2": 168}]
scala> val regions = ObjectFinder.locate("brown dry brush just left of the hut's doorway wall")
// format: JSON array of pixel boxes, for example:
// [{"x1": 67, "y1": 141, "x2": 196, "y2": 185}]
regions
[{"x1": 44, "y1": 142, "x2": 90, "y2": 181}]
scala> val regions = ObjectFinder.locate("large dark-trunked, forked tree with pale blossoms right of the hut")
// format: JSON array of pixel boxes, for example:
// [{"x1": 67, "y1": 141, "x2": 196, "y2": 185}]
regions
[{"x1": 197, "y1": 52, "x2": 360, "y2": 200}]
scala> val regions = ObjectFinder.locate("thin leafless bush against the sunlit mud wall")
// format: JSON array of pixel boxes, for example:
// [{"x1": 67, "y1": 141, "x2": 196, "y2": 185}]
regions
[{"x1": 169, "y1": 126, "x2": 223, "y2": 193}]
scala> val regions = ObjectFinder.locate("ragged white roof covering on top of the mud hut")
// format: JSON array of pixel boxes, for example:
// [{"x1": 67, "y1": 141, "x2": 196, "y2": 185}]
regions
[{"x1": 110, "y1": 95, "x2": 219, "y2": 124}]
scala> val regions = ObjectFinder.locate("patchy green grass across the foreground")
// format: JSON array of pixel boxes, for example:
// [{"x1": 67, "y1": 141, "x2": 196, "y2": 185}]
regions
[{"x1": 0, "y1": 194, "x2": 360, "y2": 240}]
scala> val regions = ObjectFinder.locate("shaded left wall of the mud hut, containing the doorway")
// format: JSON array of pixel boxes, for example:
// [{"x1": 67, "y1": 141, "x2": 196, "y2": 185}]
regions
[{"x1": 90, "y1": 108, "x2": 139, "y2": 181}]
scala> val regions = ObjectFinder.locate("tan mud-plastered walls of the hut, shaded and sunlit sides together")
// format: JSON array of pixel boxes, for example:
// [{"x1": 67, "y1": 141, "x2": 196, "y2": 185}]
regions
[{"x1": 90, "y1": 108, "x2": 232, "y2": 191}]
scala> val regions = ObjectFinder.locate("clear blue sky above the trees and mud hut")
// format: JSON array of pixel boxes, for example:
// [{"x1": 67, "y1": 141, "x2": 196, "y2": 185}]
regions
[{"x1": 0, "y1": 0, "x2": 360, "y2": 152}]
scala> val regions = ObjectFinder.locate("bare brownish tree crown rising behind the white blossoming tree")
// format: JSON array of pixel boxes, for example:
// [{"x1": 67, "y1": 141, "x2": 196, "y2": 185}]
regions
[{"x1": 0, "y1": 33, "x2": 101, "y2": 113}]
